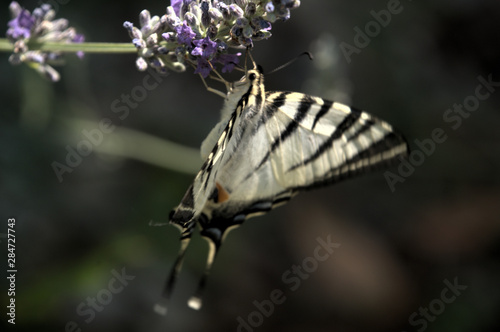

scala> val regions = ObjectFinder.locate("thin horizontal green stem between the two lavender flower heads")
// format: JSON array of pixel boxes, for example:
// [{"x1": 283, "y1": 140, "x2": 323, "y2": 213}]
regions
[{"x1": 0, "y1": 38, "x2": 137, "y2": 53}]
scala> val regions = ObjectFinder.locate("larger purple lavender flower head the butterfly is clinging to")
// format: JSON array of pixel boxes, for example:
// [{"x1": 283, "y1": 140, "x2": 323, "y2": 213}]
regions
[{"x1": 123, "y1": 0, "x2": 300, "y2": 77}]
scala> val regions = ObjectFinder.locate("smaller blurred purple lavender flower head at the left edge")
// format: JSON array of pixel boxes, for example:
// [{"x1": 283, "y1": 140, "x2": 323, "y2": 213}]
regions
[{"x1": 7, "y1": 1, "x2": 85, "y2": 82}]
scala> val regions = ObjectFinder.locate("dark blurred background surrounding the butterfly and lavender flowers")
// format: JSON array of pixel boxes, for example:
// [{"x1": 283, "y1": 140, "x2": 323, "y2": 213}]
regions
[{"x1": 0, "y1": 0, "x2": 500, "y2": 332}]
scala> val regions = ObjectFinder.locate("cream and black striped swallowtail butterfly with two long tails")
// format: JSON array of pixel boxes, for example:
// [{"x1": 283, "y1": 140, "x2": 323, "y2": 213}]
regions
[{"x1": 155, "y1": 53, "x2": 408, "y2": 314}]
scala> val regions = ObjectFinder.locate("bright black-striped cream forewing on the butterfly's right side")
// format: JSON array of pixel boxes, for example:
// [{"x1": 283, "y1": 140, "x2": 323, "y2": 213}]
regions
[{"x1": 261, "y1": 92, "x2": 408, "y2": 190}]
